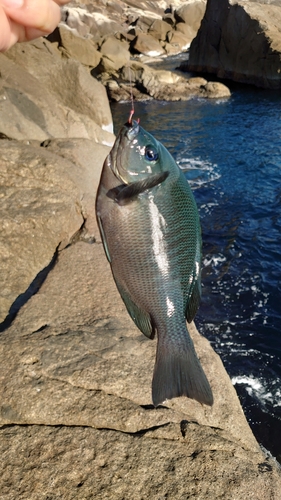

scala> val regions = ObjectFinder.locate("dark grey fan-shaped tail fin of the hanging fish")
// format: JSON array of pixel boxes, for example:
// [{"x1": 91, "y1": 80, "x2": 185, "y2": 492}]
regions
[{"x1": 152, "y1": 330, "x2": 213, "y2": 406}]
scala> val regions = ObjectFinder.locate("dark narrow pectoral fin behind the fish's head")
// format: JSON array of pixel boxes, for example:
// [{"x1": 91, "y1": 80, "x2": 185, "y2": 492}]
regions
[{"x1": 106, "y1": 171, "x2": 169, "y2": 205}]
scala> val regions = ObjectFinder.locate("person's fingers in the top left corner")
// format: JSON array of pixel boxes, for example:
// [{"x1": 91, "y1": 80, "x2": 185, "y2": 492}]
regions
[{"x1": 0, "y1": 0, "x2": 69, "y2": 52}]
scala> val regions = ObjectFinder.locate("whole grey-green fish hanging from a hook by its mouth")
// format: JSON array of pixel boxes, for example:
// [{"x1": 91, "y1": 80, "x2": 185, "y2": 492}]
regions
[{"x1": 96, "y1": 118, "x2": 213, "y2": 407}]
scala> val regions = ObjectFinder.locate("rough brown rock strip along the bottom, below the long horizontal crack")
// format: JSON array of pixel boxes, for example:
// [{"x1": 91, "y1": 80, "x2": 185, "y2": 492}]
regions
[{"x1": 0, "y1": 424, "x2": 279, "y2": 500}]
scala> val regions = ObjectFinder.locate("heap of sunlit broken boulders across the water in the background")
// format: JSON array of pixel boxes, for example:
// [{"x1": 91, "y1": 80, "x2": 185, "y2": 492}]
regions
[{"x1": 45, "y1": 0, "x2": 230, "y2": 102}]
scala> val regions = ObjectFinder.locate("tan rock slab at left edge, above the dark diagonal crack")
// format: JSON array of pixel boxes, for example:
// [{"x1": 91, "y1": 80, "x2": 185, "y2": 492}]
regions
[{"x1": 0, "y1": 141, "x2": 77, "y2": 323}]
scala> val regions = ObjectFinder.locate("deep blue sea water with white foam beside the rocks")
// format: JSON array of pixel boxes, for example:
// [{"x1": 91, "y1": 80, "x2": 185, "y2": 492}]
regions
[{"x1": 112, "y1": 88, "x2": 281, "y2": 460}]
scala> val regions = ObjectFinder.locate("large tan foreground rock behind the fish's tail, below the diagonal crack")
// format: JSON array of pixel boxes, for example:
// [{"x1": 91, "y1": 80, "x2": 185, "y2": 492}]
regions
[{"x1": 0, "y1": 242, "x2": 281, "y2": 500}]
